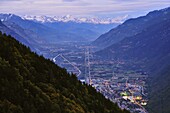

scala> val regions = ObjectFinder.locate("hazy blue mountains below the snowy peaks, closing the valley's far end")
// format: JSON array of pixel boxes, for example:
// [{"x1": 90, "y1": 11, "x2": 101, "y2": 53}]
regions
[{"x1": 0, "y1": 14, "x2": 119, "y2": 45}]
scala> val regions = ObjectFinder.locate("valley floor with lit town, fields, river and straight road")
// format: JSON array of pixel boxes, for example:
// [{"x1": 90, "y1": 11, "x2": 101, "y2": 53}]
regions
[{"x1": 43, "y1": 43, "x2": 148, "y2": 113}]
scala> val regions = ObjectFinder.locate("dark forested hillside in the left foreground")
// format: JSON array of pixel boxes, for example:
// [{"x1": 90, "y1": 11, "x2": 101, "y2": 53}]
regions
[{"x1": 0, "y1": 33, "x2": 128, "y2": 113}]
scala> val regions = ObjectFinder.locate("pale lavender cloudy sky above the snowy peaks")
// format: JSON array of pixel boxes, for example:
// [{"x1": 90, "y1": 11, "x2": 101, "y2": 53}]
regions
[{"x1": 0, "y1": 0, "x2": 170, "y2": 17}]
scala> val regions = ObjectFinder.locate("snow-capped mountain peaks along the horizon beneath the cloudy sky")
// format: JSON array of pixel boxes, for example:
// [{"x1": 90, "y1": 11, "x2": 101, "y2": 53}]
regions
[{"x1": 22, "y1": 15, "x2": 128, "y2": 24}]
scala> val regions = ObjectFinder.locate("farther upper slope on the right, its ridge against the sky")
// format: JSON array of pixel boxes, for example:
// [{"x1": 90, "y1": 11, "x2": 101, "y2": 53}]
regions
[{"x1": 92, "y1": 8, "x2": 170, "y2": 48}]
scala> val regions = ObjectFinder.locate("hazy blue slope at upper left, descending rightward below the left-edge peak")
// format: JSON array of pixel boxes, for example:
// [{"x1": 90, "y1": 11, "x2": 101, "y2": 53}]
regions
[{"x1": 0, "y1": 14, "x2": 57, "y2": 42}]
